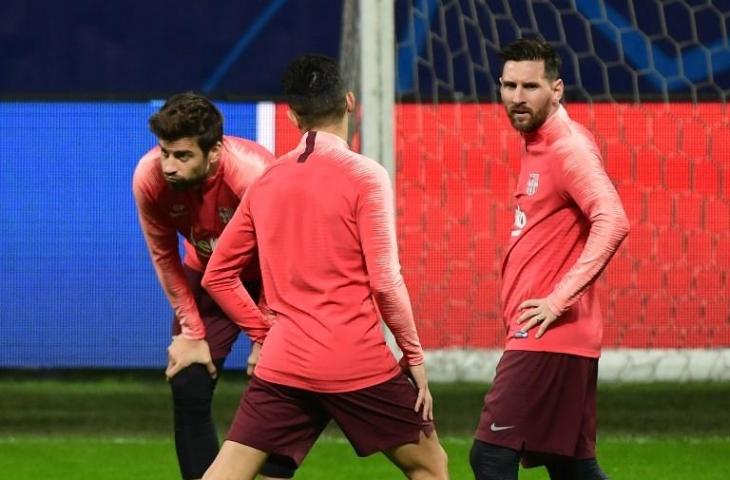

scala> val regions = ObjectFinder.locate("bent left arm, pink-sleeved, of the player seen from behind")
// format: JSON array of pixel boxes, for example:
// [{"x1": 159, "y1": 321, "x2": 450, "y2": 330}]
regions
[{"x1": 202, "y1": 189, "x2": 269, "y2": 343}]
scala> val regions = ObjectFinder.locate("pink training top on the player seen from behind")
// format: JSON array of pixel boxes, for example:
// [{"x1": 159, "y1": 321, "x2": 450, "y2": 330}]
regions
[{"x1": 203, "y1": 131, "x2": 423, "y2": 392}]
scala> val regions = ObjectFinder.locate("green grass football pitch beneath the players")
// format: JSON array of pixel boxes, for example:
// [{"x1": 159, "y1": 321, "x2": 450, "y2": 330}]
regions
[{"x1": 0, "y1": 372, "x2": 730, "y2": 480}]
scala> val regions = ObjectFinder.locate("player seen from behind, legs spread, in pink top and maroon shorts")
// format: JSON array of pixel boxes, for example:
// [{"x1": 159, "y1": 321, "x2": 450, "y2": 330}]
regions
[{"x1": 203, "y1": 55, "x2": 448, "y2": 480}]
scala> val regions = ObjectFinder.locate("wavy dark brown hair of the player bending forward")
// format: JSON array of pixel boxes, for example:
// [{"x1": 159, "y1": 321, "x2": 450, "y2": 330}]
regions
[{"x1": 150, "y1": 92, "x2": 223, "y2": 155}]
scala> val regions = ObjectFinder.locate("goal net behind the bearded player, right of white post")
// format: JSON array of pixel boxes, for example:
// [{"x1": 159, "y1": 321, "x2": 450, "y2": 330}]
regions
[{"x1": 341, "y1": 0, "x2": 730, "y2": 380}]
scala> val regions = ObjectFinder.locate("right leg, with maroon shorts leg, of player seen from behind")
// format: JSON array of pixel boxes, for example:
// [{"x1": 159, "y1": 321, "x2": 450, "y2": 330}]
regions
[{"x1": 320, "y1": 373, "x2": 448, "y2": 480}]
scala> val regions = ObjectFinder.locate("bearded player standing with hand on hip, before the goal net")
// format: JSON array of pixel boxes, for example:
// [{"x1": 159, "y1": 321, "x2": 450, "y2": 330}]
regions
[{"x1": 470, "y1": 39, "x2": 629, "y2": 480}]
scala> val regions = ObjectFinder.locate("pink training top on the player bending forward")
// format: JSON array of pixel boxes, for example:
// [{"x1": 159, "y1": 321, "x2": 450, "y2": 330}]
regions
[{"x1": 132, "y1": 136, "x2": 274, "y2": 339}]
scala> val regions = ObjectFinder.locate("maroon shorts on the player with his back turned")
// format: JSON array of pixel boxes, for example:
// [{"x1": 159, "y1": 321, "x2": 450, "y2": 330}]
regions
[{"x1": 226, "y1": 373, "x2": 434, "y2": 465}]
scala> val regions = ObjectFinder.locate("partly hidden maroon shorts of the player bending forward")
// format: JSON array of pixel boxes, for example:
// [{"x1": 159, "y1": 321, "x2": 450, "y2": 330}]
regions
[{"x1": 172, "y1": 264, "x2": 261, "y2": 360}]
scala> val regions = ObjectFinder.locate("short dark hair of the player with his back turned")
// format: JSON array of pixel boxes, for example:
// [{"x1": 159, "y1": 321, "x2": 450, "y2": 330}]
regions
[{"x1": 281, "y1": 54, "x2": 347, "y2": 130}]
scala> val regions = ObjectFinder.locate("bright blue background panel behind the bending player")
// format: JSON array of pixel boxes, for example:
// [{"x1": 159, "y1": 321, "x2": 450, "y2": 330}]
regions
[{"x1": 0, "y1": 101, "x2": 256, "y2": 368}]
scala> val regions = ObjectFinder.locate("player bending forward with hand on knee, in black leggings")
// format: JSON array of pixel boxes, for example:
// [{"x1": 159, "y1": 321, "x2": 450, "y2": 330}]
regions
[{"x1": 133, "y1": 93, "x2": 294, "y2": 480}]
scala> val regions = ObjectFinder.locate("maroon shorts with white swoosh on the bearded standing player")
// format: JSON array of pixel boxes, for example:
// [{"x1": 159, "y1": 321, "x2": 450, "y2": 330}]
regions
[{"x1": 475, "y1": 350, "x2": 598, "y2": 466}]
